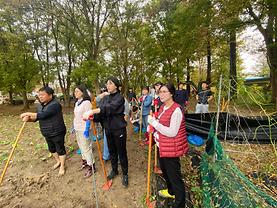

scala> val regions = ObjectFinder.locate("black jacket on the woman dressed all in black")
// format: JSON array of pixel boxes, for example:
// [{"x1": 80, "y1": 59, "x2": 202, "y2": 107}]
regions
[{"x1": 99, "y1": 92, "x2": 127, "y2": 131}]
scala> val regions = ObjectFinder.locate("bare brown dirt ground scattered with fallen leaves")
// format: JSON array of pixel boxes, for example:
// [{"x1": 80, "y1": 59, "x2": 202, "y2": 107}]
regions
[{"x1": 0, "y1": 103, "x2": 277, "y2": 208}]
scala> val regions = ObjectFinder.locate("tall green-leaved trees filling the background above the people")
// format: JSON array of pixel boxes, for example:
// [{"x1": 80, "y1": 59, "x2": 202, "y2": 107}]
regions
[{"x1": 0, "y1": 0, "x2": 277, "y2": 108}]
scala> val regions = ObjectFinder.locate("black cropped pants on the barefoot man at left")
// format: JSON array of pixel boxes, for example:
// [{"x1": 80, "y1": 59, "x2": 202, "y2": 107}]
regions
[{"x1": 45, "y1": 133, "x2": 66, "y2": 155}]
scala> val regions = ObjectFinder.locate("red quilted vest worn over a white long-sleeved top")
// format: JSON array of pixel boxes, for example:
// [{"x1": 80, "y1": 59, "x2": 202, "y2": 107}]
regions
[{"x1": 158, "y1": 102, "x2": 189, "y2": 157}]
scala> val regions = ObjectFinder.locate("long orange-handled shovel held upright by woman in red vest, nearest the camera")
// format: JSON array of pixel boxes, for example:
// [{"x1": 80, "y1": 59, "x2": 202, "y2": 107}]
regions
[{"x1": 146, "y1": 113, "x2": 155, "y2": 208}]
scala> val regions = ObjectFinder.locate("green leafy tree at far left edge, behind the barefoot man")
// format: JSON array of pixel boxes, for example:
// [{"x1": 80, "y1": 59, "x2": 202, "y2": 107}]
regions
[{"x1": 0, "y1": 33, "x2": 39, "y2": 109}]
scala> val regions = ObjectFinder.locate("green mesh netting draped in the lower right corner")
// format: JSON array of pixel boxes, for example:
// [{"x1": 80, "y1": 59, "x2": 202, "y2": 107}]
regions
[{"x1": 200, "y1": 124, "x2": 277, "y2": 208}]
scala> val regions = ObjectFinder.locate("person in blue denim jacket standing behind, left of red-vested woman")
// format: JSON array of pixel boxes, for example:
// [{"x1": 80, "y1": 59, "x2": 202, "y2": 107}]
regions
[{"x1": 140, "y1": 86, "x2": 152, "y2": 132}]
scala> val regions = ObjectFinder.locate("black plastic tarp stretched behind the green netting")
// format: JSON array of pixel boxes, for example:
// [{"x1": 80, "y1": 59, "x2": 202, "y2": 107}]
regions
[{"x1": 185, "y1": 112, "x2": 277, "y2": 143}]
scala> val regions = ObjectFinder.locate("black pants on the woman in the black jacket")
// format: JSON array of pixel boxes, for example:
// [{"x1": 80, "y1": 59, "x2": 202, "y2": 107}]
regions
[{"x1": 106, "y1": 128, "x2": 128, "y2": 175}]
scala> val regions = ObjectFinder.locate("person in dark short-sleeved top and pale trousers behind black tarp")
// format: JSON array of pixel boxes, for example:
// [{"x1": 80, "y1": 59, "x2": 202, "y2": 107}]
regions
[{"x1": 195, "y1": 81, "x2": 213, "y2": 113}]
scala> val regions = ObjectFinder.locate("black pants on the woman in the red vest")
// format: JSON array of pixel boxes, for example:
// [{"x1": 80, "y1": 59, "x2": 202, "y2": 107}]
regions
[{"x1": 159, "y1": 157, "x2": 186, "y2": 208}]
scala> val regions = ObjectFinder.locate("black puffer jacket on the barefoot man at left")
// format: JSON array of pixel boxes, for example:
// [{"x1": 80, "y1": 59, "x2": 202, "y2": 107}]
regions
[{"x1": 37, "y1": 99, "x2": 66, "y2": 137}]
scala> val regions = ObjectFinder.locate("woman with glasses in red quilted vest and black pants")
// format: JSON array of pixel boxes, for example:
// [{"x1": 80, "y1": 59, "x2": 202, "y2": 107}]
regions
[{"x1": 148, "y1": 83, "x2": 189, "y2": 208}]
